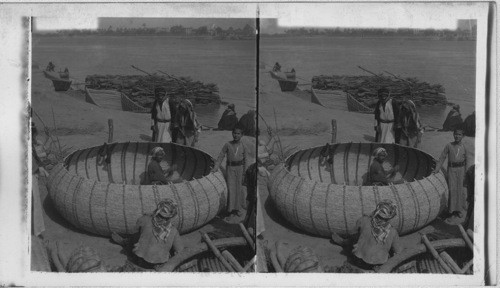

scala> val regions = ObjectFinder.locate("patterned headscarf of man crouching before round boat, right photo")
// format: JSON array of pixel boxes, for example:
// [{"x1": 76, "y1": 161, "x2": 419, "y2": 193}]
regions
[{"x1": 371, "y1": 200, "x2": 397, "y2": 243}]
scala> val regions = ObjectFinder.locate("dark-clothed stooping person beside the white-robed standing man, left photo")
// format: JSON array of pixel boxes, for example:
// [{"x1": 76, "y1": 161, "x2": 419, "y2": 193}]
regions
[{"x1": 173, "y1": 99, "x2": 201, "y2": 147}]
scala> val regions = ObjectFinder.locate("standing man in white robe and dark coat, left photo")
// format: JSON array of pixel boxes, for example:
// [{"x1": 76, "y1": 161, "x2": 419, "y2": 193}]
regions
[{"x1": 151, "y1": 87, "x2": 172, "y2": 143}]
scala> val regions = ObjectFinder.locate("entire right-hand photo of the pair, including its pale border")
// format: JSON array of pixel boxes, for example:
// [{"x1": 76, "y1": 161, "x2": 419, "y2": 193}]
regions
[{"x1": 257, "y1": 3, "x2": 487, "y2": 275}]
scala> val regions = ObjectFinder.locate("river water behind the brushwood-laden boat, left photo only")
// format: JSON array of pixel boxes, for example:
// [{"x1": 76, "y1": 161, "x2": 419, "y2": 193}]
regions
[{"x1": 32, "y1": 36, "x2": 257, "y2": 127}]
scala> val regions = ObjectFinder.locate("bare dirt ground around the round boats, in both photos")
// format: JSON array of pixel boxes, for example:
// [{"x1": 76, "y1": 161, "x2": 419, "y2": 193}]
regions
[{"x1": 32, "y1": 69, "x2": 474, "y2": 272}]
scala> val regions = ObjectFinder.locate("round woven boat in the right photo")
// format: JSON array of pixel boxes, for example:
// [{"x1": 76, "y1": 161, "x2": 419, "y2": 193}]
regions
[{"x1": 270, "y1": 143, "x2": 448, "y2": 237}]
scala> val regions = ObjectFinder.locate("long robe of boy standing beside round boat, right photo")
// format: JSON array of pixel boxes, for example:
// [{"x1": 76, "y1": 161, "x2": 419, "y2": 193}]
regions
[{"x1": 439, "y1": 142, "x2": 467, "y2": 213}]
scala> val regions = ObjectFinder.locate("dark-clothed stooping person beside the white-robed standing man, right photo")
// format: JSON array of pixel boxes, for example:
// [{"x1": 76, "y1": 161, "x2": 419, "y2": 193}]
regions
[{"x1": 398, "y1": 100, "x2": 423, "y2": 148}]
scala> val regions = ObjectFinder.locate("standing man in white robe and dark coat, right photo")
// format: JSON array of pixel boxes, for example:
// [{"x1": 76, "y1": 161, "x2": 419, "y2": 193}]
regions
[{"x1": 375, "y1": 87, "x2": 401, "y2": 143}]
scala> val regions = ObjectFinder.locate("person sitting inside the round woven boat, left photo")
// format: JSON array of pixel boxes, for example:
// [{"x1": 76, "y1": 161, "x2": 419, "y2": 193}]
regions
[{"x1": 145, "y1": 147, "x2": 182, "y2": 185}]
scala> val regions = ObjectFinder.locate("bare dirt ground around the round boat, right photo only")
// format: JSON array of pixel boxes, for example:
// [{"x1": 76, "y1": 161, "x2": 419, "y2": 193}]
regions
[{"x1": 259, "y1": 70, "x2": 475, "y2": 267}]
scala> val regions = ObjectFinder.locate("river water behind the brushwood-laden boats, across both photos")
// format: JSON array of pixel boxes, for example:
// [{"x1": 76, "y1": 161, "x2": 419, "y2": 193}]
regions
[{"x1": 32, "y1": 36, "x2": 476, "y2": 127}]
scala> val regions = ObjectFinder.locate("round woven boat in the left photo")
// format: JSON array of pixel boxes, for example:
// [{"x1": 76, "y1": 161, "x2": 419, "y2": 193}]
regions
[{"x1": 48, "y1": 142, "x2": 227, "y2": 236}]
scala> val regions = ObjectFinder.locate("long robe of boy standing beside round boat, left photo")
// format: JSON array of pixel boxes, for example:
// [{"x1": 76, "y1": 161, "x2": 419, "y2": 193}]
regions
[{"x1": 215, "y1": 140, "x2": 247, "y2": 212}]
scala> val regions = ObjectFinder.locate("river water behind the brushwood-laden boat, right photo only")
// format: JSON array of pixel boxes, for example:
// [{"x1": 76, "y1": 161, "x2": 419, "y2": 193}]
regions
[{"x1": 259, "y1": 37, "x2": 476, "y2": 127}]
